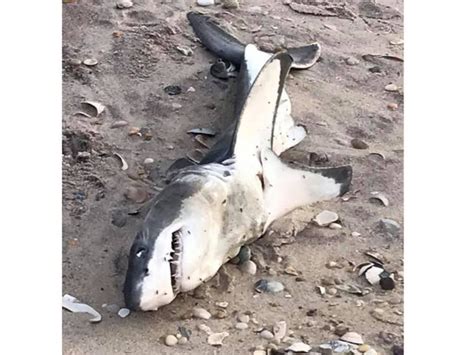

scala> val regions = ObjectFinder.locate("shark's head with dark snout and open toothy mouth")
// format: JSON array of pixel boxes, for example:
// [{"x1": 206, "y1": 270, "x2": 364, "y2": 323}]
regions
[{"x1": 123, "y1": 177, "x2": 223, "y2": 311}]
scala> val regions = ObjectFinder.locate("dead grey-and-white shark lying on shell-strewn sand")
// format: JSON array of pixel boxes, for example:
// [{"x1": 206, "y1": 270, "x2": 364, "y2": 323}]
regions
[{"x1": 123, "y1": 13, "x2": 352, "y2": 311}]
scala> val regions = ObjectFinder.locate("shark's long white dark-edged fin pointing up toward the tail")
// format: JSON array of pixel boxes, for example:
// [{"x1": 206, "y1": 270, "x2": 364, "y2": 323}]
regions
[{"x1": 231, "y1": 52, "x2": 292, "y2": 170}]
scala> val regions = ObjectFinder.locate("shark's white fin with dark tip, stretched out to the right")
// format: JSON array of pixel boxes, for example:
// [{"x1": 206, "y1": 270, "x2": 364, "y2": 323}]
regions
[{"x1": 261, "y1": 149, "x2": 352, "y2": 229}]
